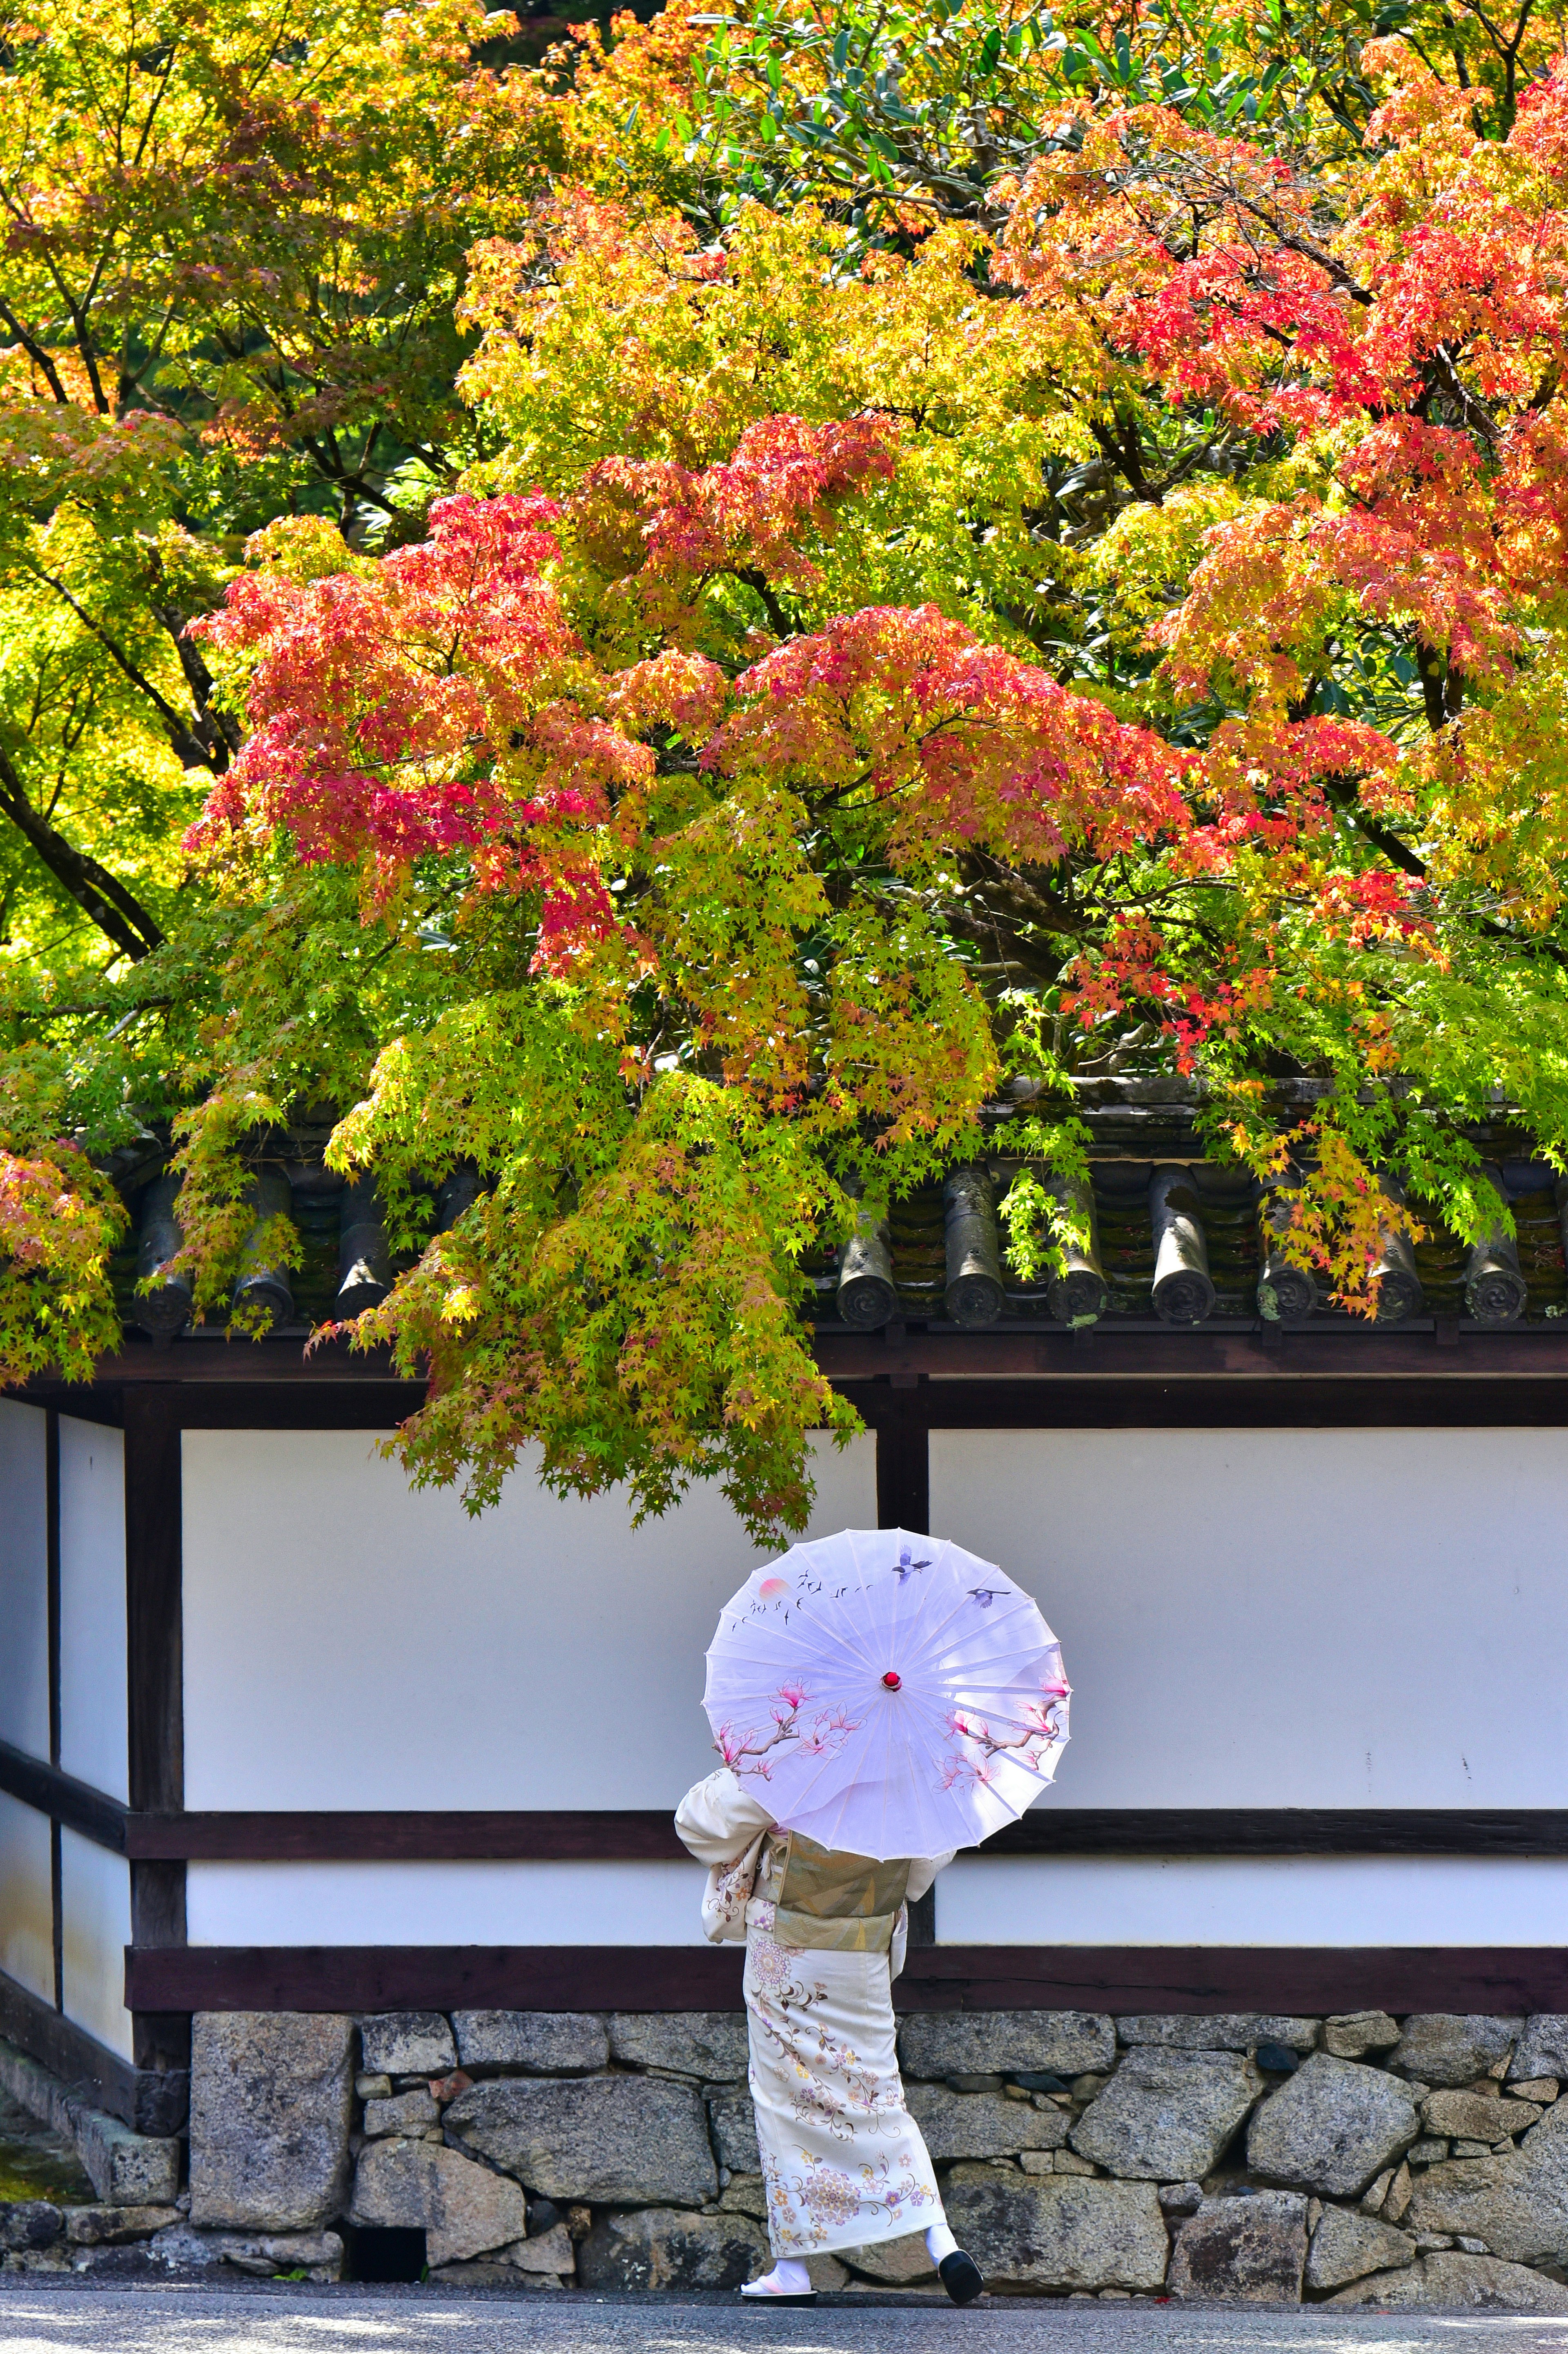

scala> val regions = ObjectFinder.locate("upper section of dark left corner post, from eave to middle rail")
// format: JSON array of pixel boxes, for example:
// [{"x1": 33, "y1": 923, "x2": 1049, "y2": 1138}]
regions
[{"x1": 125, "y1": 1387, "x2": 186, "y2": 1812}]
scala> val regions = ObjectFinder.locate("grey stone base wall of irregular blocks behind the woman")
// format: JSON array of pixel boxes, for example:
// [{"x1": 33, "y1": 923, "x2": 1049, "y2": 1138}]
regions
[{"x1": 122, "y1": 2010, "x2": 1568, "y2": 2312}]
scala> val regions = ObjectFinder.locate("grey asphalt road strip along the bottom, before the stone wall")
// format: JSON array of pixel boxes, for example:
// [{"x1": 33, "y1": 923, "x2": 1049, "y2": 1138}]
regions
[{"x1": 0, "y1": 2281, "x2": 1568, "y2": 2354}]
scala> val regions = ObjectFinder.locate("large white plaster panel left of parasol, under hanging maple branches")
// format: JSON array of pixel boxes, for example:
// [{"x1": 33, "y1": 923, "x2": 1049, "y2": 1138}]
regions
[{"x1": 184, "y1": 1431, "x2": 876, "y2": 1808}]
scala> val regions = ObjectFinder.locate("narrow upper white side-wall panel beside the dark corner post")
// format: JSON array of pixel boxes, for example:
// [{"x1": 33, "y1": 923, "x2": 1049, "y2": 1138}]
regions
[{"x1": 59, "y1": 1415, "x2": 129, "y2": 1799}]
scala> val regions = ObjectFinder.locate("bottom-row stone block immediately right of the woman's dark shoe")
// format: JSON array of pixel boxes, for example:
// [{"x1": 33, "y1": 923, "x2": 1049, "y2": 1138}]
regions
[{"x1": 944, "y1": 2166, "x2": 1170, "y2": 2290}]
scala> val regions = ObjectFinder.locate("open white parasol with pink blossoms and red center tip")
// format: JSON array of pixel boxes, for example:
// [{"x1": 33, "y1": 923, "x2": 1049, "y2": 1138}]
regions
[{"x1": 702, "y1": 1528, "x2": 1071, "y2": 1862}]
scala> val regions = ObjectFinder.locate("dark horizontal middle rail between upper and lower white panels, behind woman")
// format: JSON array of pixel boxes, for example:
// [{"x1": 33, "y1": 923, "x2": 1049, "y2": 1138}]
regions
[{"x1": 128, "y1": 1798, "x2": 1568, "y2": 1855}]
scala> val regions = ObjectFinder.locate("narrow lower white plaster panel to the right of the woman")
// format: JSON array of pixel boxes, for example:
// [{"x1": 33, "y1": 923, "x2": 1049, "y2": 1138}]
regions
[{"x1": 937, "y1": 1855, "x2": 1568, "y2": 1947}]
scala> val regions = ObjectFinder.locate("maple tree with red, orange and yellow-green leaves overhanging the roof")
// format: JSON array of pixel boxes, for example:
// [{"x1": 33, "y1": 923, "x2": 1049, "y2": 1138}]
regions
[{"x1": 0, "y1": 7, "x2": 1568, "y2": 1528}]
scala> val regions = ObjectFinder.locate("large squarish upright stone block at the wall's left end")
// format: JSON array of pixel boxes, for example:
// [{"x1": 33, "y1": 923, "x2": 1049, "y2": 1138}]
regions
[{"x1": 188, "y1": 2010, "x2": 353, "y2": 2231}]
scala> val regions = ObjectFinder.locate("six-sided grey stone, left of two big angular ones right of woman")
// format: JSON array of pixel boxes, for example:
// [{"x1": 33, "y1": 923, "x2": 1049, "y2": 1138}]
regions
[{"x1": 1069, "y1": 2046, "x2": 1252, "y2": 2182}]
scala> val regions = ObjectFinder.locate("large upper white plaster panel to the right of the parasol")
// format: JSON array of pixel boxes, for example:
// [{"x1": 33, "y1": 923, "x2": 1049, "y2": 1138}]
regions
[{"x1": 930, "y1": 1429, "x2": 1568, "y2": 1808}]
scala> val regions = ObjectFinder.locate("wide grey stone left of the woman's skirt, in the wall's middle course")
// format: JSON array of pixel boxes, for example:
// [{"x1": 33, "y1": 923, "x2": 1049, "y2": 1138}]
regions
[{"x1": 445, "y1": 2076, "x2": 715, "y2": 2203}]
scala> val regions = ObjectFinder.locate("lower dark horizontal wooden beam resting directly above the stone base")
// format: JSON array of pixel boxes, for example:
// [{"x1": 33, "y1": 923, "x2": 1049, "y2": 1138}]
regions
[{"x1": 125, "y1": 1944, "x2": 1568, "y2": 2017}]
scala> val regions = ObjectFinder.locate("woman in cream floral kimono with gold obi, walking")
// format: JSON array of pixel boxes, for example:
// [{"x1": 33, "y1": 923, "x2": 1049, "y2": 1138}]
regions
[{"x1": 676, "y1": 1766, "x2": 984, "y2": 2305}]
